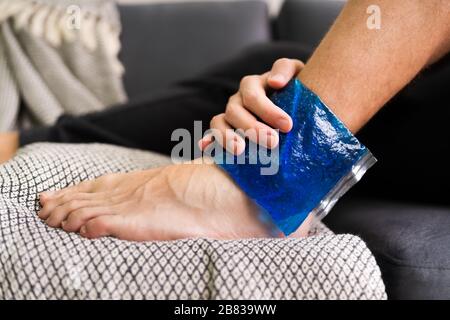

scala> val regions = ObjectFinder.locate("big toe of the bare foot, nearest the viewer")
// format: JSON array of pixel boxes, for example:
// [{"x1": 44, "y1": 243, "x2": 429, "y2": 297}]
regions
[{"x1": 80, "y1": 215, "x2": 122, "y2": 239}]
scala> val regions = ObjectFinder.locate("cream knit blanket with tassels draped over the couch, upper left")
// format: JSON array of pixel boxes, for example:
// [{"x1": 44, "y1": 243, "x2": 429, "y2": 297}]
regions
[{"x1": 0, "y1": 0, "x2": 126, "y2": 132}]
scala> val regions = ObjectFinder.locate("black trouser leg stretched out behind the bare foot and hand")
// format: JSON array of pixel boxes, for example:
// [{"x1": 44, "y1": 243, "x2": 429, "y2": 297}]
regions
[{"x1": 20, "y1": 44, "x2": 309, "y2": 154}]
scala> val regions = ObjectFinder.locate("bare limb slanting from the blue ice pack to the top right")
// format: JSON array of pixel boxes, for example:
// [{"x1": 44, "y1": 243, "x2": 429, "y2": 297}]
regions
[{"x1": 299, "y1": 0, "x2": 450, "y2": 132}]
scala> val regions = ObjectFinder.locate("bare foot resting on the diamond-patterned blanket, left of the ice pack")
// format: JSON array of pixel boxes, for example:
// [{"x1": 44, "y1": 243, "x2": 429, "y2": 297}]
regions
[{"x1": 39, "y1": 160, "x2": 292, "y2": 241}]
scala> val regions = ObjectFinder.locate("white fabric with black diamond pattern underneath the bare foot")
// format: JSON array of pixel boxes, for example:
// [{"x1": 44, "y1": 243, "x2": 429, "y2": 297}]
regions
[{"x1": 0, "y1": 144, "x2": 386, "y2": 299}]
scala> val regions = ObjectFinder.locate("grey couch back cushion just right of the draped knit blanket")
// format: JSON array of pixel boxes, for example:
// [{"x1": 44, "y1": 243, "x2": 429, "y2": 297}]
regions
[{"x1": 119, "y1": 1, "x2": 270, "y2": 98}]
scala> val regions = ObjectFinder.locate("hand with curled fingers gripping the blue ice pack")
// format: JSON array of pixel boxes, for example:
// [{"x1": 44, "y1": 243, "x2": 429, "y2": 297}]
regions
[{"x1": 199, "y1": 58, "x2": 304, "y2": 155}]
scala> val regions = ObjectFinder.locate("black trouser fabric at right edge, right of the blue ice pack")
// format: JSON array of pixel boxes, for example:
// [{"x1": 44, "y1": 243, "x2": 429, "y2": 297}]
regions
[{"x1": 354, "y1": 55, "x2": 450, "y2": 206}]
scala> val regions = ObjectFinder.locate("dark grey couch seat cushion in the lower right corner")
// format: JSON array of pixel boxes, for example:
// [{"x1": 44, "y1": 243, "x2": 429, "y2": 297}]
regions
[{"x1": 325, "y1": 197, "x2": 450, "y2": 299}]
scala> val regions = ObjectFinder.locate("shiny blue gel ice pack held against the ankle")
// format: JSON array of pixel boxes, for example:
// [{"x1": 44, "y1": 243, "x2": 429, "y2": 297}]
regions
[{"x1": 214, "y1": 79, "x2": 376, "y2": 235}]
